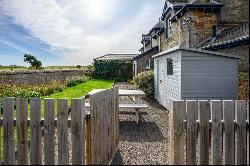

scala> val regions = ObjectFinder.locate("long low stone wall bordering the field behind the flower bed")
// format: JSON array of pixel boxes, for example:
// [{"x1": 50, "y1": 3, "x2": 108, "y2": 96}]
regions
[{"x1": 0, "y1": 70, "x2": 92, "y2": 85}]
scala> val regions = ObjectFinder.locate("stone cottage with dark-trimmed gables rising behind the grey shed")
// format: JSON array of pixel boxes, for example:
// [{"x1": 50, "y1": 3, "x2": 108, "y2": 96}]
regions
[{"x1": 135, "y1": 0, "x2": 249, "y2": 74}]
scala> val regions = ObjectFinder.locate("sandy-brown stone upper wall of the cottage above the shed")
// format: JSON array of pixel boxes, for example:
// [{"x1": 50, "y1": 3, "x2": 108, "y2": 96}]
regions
[{"x1": 160, "y1": 9, "x2": 218, "y2": 51}]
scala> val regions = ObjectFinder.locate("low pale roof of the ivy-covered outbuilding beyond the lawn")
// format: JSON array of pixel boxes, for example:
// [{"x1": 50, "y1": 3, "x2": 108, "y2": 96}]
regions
[{"x1": 94, "y1": 54, "x2": 138, "y2": 61}]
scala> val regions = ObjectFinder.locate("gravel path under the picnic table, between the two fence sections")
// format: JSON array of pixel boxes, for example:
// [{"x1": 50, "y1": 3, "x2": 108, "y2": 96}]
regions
[{"x1": 111, "y1": 83, "x2": 168, "y2": 165}]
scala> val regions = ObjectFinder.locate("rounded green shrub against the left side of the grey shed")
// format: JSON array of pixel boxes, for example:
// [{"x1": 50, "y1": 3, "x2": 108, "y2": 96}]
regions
[{"x1": 133, "y1": 70, "x2": 154, "y2": 98}]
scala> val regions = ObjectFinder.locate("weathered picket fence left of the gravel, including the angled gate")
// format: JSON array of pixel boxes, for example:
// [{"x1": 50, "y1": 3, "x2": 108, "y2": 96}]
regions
[{"x1": 0, "y1": 87, "x2": 119, "y2": 165}]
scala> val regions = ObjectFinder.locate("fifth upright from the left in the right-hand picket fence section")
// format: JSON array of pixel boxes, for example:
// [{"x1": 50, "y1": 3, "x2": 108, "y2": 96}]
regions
[{"x1": 223, "y1": 100, "x2": 234, "y2": 165}]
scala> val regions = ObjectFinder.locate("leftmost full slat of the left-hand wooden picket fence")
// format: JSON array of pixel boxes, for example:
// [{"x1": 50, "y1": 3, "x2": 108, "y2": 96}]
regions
[{"x1": 3, "y1": 98, "x2": 15, "y2": 165}]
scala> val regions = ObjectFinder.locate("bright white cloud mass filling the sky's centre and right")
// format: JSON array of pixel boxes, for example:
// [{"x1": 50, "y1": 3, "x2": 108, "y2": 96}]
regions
[{"x1": 0, "y1": 0, "x2": 164, "y2": 64}]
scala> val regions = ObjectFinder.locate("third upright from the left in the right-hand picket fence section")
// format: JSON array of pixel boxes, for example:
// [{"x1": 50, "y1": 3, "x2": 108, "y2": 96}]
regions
[{"x1": 198, "y1": 101, "x2": 210, "y2": 165}]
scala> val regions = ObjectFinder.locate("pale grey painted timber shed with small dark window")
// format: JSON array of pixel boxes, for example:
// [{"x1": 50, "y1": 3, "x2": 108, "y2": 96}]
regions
[{"x1": 153, "y1": 47, "x2": 239, "y2": 108}]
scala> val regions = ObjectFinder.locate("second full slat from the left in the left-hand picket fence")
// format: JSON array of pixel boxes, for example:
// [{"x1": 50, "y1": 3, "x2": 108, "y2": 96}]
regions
[{"x1": 16, "y1": 98, "x2": 28, "y2": 165}]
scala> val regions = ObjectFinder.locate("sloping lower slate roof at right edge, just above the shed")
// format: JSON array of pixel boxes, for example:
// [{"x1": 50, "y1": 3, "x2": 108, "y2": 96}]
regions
[{"x1": 196, "y1": 23, "x2": 249, "y2": 50}]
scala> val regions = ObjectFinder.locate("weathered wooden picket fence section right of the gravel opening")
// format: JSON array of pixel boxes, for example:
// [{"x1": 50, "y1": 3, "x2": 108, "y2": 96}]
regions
[{"x1": 168, "y1": 100, "x2": 249, "y2": 165}]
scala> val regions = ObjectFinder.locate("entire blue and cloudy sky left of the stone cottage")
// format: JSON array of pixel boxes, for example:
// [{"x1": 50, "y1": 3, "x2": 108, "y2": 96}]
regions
[{"x1": 0, "y1": 0, "x2": 165, "y2": 66}]
